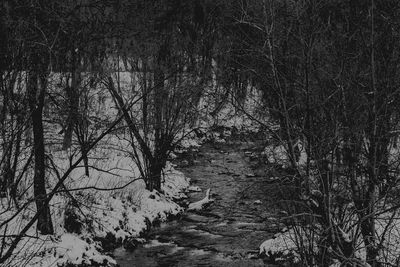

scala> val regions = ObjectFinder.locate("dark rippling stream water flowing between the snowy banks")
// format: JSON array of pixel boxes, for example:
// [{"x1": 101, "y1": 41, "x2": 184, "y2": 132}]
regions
[{"x1": 114, "y1": 144, "x2": 278, "y2": 267}]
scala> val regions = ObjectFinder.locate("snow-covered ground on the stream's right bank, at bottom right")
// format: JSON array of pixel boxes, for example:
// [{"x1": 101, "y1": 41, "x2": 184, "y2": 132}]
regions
[{"x1": 259, "y1": 193, "x2": 400, "y2": 267}]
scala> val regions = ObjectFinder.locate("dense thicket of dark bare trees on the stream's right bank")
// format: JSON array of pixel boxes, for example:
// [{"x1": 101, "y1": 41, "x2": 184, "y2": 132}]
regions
[{"x1": 223, "y1": 1, "x2": 399, "y2": 266}]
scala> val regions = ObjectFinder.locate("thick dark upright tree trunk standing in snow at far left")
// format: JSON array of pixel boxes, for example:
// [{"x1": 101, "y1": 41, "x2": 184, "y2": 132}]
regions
[{"x1": 27, "y1": 63, "x2": 54, "y2": 235}]
